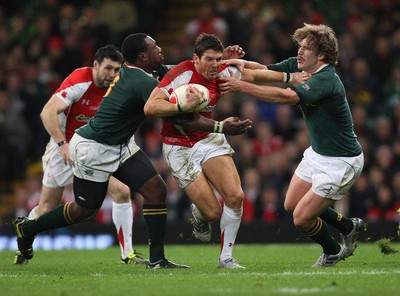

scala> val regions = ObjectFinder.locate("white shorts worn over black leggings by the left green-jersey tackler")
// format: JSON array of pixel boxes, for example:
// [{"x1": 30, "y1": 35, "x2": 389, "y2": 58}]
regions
[{"x1": 69, "y1": 133, "x2": 140, "y2": 182}]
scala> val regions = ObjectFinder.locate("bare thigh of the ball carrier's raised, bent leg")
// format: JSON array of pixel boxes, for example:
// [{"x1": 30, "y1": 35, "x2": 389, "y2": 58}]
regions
[{"x1": 184, "y1": 172, "x2": 222, "y2": 220}]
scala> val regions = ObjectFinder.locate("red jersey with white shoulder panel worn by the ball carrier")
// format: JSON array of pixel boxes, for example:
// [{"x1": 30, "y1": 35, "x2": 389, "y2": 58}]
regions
[{"x1": 158, "y1": 60, "x2": 228, "y2": 147}]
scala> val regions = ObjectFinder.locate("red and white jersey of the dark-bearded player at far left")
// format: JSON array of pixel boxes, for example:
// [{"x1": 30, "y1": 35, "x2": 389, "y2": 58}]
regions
[{"x1": 54, "y1": 67, "x2": 107, "y2": 142}]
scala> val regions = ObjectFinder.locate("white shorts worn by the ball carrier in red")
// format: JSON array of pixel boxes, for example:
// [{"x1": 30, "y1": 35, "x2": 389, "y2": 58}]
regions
[{"x1": 163, "y1": 133, "x2": 235, "y2": 188}]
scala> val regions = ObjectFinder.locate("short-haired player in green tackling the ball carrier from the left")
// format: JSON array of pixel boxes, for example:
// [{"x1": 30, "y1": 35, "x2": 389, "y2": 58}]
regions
[{"x1": 14, "y1": 33, "x2": 251, "y2": 269}]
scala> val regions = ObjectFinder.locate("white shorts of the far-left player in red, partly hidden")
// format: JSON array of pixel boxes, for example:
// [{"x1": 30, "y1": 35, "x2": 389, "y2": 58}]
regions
[{"x1": 42, "y1": 139, "x2": 73, "y2": 188}]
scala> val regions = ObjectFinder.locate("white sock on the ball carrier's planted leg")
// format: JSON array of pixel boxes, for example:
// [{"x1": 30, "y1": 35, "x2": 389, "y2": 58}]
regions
[{"x1": 219, "y1": 204, "x2": 243, "y2": 260}]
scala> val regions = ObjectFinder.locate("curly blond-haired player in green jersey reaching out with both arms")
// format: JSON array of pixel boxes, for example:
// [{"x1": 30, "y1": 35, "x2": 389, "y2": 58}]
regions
[{"x1": 220, "y1": 24, "x2": 365, "y2": 267}]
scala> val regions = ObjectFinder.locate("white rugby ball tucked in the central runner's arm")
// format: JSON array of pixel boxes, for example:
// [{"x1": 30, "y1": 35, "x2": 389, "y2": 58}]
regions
[{"x1": 169, "y1": 83, "x2": 210, "y2": 112}]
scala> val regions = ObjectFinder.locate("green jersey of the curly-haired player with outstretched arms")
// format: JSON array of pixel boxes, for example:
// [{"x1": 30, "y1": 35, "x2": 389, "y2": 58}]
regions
[{"x1": 268, "y1": 57, "x2": 362, "y2": 156}]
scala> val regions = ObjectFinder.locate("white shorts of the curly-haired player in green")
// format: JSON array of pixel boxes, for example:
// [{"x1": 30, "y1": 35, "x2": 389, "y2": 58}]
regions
[{"x1": 295, "y1": 147, "x2": 364, "y2": 200}]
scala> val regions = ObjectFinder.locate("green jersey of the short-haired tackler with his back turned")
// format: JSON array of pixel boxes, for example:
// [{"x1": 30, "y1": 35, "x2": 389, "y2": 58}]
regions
[{"x1": 76, "y1": 65, "x2": 169, "y2": 145}]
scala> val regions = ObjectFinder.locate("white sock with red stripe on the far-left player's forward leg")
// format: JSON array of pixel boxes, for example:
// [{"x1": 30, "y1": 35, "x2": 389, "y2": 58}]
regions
[{"x1": 112, "y1": 201, "x2": 133, "y2": 259}]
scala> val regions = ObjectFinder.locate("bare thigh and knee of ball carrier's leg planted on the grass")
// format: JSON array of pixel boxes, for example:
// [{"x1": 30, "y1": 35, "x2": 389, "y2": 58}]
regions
[{"x1": 203, "y1": 155, "x2": 244, "y2": 208}]
